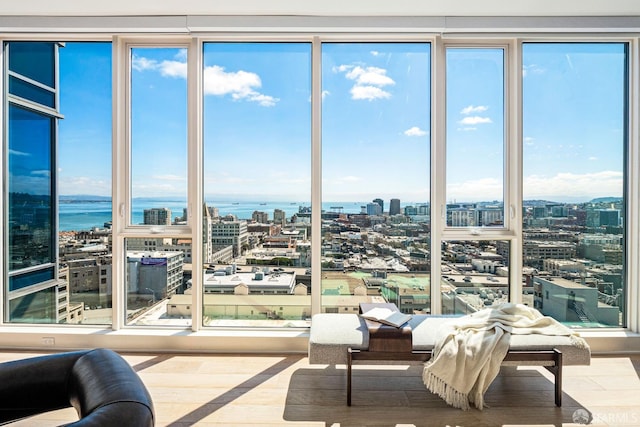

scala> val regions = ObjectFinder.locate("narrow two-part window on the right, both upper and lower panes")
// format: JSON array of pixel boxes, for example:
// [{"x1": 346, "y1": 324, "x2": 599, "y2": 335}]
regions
[{"x1": 440, "y1": 44, "x2": 510, "y2": 314}]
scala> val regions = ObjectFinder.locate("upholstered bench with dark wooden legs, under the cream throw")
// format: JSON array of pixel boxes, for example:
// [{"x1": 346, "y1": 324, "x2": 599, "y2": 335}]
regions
[{"x1": 309, "y1": 313, "x2": 591, "y2": 406}]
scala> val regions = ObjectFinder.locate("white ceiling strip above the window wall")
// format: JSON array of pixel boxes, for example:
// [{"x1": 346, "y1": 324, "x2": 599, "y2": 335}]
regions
[{"x1": 0, "y1": 0, "x2": 640, "y2": 17}]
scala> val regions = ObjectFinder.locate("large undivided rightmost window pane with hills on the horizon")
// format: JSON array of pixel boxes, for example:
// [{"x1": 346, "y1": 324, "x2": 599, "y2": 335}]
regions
[{"x1": 522, "y1": 43, "x2": 628, "y2": 326}]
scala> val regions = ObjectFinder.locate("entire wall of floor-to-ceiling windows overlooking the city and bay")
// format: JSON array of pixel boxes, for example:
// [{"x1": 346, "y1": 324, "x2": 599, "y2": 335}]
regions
[{"x1": 3, "y1": 30, "x2": 637, "y2": 348}]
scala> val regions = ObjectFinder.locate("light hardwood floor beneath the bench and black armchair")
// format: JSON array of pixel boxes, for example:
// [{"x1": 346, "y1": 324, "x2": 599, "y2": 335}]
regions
[{"x1": 0, "y1": 352, "x2": 640, "y2": 427}]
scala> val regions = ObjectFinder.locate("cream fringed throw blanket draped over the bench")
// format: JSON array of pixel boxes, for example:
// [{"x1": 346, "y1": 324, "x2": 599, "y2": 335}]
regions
[{"x1": 422, "y1": 303, "x2": 587, "y2": 410}]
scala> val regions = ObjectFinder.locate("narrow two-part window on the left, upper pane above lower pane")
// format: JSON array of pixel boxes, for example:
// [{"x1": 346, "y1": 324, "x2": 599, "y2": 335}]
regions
[{"x1": 124, "y1": 41, "x2": 192, "y2": 328}]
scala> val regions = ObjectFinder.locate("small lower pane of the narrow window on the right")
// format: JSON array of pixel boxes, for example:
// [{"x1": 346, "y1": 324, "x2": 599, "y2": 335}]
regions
[{"x1": 440, "y1": 240, "x2": 510, "y2": 314}]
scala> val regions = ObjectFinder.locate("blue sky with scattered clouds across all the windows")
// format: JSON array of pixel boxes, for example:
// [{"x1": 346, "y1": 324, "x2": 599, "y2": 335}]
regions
[{"x1": 59, "y1": 43, "x2": 624, "y2": 203}]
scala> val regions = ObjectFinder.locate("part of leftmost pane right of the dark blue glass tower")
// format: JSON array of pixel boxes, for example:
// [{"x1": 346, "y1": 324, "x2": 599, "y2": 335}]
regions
[{"x1": 58, "y1": 42, "x2": 112, "y2": 324}]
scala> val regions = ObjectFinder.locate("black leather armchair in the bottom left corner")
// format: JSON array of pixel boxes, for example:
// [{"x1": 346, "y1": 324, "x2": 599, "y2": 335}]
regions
[{"x1": 0, "y1": 349, "x2": 155, "y2": 427}]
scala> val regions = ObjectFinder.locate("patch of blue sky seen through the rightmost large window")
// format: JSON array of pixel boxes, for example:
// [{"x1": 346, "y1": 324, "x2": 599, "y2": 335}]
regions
[{"x1": 523, "y1": 43, "x2": 625, "y2": 201}]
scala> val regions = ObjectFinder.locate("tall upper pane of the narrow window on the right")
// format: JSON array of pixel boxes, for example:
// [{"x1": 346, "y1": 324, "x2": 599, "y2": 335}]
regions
[{"x1": 446, "y1": 48, "x2": 505, "y2": 227}]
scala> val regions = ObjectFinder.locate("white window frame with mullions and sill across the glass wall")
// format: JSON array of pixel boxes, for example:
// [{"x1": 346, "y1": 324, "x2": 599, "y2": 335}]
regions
[{"x1": 0, "y1": 17, "x2": 640, "y2": 352}]
